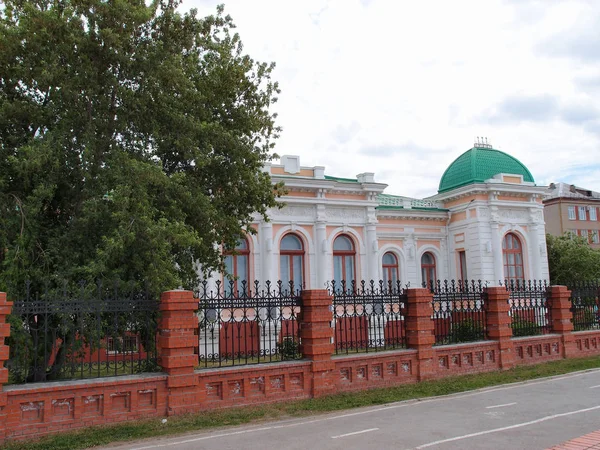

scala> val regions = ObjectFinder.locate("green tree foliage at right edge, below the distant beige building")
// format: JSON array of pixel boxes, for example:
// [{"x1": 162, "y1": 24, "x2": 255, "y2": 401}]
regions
[{"x1": 546, "y1": 233, "x2": 600, "y2": 284}]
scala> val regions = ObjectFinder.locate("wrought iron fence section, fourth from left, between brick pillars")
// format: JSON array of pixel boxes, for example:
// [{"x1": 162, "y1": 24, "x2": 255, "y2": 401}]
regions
[{"x1": 429, "y1": 280, "x2": 487, "y2": 345}]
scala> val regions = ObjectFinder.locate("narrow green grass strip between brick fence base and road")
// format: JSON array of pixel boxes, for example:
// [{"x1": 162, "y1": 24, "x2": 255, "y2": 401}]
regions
[{"x1": 3, "y1": 356, "x2": 600, "y2": 450}]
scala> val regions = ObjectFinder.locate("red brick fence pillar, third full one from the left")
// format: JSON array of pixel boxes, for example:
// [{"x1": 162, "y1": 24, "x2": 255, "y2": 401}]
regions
[{"x1": 405, "y1": 288, "x2": 437, "y2": 381}]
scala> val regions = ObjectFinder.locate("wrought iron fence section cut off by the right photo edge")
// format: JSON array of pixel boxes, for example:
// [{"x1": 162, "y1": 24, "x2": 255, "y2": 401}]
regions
[{"x1": 567, "y1": 281, "x2": 600, "y2": 331}]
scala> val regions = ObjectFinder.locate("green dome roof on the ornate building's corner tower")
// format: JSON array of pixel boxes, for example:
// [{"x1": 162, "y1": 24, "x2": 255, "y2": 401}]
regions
[{"x1": 438, "y1": 147, "x2": 534, "y2": 192}]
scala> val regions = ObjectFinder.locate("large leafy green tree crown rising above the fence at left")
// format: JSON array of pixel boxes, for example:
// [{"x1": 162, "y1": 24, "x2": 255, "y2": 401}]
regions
[{"x1": 0, "y1": 0, "x2": 279, "y2": 292}]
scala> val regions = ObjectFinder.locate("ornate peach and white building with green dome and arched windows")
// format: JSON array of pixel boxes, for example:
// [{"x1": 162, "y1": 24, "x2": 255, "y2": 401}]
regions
[{"x1": 207, "y1": 143, "x2": 548, "y2": 289}]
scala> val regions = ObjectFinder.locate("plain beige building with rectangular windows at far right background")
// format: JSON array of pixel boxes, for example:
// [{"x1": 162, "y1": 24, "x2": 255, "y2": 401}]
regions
[{"x1": 544, "y1": 183, "x2": 600, "y2": 249}]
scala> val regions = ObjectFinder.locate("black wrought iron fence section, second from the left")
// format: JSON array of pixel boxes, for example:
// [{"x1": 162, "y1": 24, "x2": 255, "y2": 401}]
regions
[{"x1": 197, "y1": 280, "x2": 302, "y2": 368}]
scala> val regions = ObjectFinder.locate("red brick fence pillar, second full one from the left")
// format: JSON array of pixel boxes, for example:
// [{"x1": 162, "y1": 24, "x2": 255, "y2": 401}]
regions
[{"x1": 299, "y1": 289, "x2": 335, "y2": 397}]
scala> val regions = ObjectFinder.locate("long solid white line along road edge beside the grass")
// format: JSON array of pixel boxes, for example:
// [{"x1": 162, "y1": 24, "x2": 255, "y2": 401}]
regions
[{"x1": 122, "y1": 369, "x2": 600, "y2": 450}]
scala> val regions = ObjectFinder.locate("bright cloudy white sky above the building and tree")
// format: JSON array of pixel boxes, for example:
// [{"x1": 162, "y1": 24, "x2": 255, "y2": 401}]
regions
[{"x1": 180, "y1": 0, "x2": 600, "y2": 198}]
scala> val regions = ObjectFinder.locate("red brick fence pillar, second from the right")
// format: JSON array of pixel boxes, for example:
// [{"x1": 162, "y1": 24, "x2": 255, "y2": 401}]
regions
[{"x1": 485, "y1": 286, "x2": 515, "y2": 370}]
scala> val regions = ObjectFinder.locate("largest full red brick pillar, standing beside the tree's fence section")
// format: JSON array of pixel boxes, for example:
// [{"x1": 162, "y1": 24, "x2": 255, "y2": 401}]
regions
[{"x1": 158, "y1": 290, "x2": 204, "y2": 415}]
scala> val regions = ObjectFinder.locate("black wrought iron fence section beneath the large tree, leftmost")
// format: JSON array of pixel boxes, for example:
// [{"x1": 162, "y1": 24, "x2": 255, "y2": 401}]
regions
[{"x1": 7, "y1": 283, "x2": 159, "y2": 383}]
